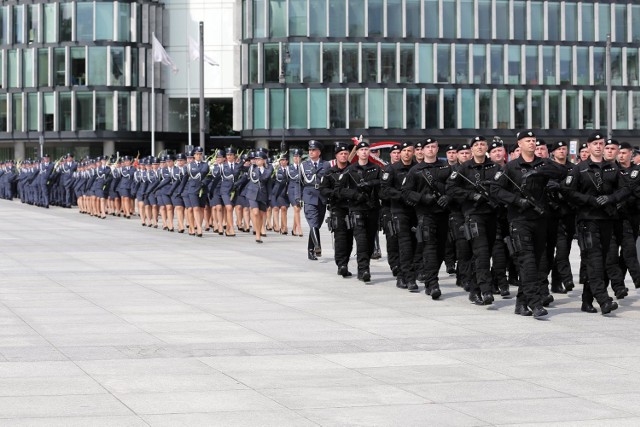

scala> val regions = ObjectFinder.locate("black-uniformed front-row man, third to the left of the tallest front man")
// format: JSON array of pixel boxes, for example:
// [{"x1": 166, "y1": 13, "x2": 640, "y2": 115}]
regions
[{"x1": 380, "y1": 142, "x2": 418, "y2": 292}]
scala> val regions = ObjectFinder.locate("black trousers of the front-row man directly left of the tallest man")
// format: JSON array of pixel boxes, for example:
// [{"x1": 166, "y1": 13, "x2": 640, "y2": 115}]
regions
[{"x1": 467, "y1": 214, "x2": 497, "y2": 293}]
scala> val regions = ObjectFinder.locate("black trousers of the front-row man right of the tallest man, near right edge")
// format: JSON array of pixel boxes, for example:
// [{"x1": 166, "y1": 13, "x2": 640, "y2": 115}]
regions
[{"x1": 578, "y1": 219, "x2": 614, "y2": 305}]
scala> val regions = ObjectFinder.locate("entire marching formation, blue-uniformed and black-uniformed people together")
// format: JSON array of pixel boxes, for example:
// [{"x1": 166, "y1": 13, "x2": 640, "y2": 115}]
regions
[{"x1": 0, "y1": 130, "x2": 640, "y2": 318}]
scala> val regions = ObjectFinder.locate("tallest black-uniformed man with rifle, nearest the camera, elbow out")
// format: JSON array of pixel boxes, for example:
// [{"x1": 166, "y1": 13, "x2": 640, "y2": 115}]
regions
[{"x1": 491, "y1": 130, "x2": 566, "y2": 318}]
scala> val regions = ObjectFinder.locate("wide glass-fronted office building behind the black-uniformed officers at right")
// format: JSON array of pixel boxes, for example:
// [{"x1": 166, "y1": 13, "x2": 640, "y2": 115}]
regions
[{"x1": 241, "y1": 0, "x2": 640, "y2": 144}]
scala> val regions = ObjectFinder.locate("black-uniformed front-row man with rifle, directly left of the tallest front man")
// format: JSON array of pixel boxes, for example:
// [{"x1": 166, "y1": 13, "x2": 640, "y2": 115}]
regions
[{"x1": 447, "y1": 136, "x2": 500, "y2": 305}]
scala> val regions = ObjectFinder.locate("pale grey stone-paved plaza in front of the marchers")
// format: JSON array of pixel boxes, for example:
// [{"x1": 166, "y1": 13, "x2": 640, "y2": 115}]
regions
[{"x1": 0, "y1": 201, "x2": 640, "y2": 427}]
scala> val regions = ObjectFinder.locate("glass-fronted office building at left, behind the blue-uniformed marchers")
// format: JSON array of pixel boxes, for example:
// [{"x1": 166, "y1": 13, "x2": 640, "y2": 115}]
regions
[{"x1": 0, "y1": 0, "x2": 162, "y2": 157}]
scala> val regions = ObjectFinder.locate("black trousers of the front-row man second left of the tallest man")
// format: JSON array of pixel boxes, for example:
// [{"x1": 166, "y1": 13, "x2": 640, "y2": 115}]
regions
[{"x1": 418, "y1": 213, "x2": 449, "y2": 288}]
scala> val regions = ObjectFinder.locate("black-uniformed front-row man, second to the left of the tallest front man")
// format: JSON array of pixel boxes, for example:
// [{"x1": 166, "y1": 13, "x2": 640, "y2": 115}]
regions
[{"x1": 402, "y1": 138, "x2": 451, "y2": 299}]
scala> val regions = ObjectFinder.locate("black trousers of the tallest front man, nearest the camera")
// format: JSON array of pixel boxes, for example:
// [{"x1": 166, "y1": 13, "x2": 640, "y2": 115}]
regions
[{"x1": 510, "y1": 218, "x2": 548, "y2": 308}]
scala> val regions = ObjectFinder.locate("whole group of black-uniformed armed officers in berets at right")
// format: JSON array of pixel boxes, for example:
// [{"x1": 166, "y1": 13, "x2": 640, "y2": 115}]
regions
[{"x1": 316, "y1": 130, "x2": 640, "y2": 318}]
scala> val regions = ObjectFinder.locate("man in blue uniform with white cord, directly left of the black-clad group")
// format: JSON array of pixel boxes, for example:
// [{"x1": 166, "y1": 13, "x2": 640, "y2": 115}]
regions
[{"x1": 300, "y1": 140, "x2": 327, "y2": 261}]
